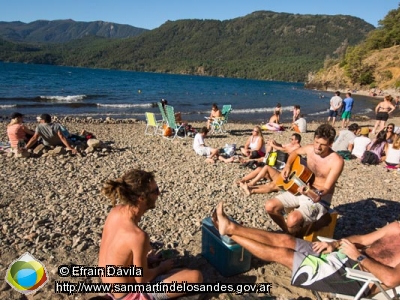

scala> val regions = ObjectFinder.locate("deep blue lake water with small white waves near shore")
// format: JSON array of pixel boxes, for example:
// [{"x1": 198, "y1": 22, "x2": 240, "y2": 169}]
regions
[{"x1": 0, "y1": 62, "x2": 377, "y2": 123}]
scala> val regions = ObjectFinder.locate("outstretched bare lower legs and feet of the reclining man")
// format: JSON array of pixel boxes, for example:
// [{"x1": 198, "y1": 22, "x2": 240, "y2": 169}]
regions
[{"x1": 217, "y1": 202, "x2": 296, "y2": 269}]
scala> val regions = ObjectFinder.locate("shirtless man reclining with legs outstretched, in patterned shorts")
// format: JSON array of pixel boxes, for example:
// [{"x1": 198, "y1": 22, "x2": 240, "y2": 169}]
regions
[{"x1": 213, "y1": 202, "x2": 400, "y2": 296}]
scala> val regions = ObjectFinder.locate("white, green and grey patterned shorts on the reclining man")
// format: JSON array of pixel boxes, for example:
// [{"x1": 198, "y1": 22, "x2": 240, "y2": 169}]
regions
[{"x1": 291, "y1": 239, "x2": 370, "y2": 296}]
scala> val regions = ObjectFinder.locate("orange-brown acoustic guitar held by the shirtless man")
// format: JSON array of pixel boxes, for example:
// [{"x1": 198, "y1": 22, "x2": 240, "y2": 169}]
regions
[{"x1": 275, "y1": 156, "x2": 314, "y2": 195}]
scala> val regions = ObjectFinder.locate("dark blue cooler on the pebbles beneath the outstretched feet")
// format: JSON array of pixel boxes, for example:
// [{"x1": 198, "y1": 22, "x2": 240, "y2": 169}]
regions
[{"x1": 201, "y1": 217, "x2": 251, "y2": 277}]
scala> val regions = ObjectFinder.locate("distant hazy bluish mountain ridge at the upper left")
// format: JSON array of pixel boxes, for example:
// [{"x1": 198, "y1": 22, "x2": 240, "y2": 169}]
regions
[{"x1": 0, "y1": 20, "x2": 148, "y2": 43}]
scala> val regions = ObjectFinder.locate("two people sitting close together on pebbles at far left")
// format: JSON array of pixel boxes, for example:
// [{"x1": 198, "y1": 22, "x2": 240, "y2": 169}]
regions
[{"x1": 7, "y1": 112, "x2": 94, "y2": 154}]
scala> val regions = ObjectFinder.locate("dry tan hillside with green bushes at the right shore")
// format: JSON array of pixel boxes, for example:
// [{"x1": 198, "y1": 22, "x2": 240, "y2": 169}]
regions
[{"x1": 307, "y1": 4, "x2": 400, "y2": 90}]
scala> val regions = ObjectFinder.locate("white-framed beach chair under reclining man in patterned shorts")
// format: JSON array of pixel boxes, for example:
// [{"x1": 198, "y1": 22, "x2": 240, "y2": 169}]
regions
[{"x1": 313, "y1": 236, "x2": 400, "y2": 300}]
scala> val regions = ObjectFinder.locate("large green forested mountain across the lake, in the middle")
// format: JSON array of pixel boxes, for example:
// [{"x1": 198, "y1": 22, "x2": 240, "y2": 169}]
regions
[{"x1": 0, "y1": 11, "x2": 374, "y2": 81}]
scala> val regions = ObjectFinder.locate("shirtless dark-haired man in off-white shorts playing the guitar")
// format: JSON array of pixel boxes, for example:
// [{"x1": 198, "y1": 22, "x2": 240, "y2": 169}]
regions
[{"x1": 265, "y1": 124, "x2": 344, "y2": 235}]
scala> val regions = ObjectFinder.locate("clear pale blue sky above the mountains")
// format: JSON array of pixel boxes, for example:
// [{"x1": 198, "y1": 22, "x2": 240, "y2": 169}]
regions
[{"x1": 0, "y1": 0, "x2": 400, "y2": 29}]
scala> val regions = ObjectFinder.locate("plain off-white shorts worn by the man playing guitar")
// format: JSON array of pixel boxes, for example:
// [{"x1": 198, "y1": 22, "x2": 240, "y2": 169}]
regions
[{"x1": 276, "y1": 192, "x2": 332, "y2": 225}]
